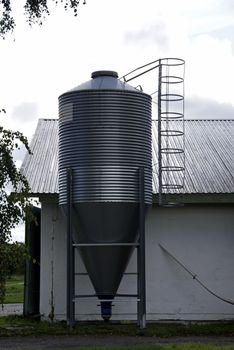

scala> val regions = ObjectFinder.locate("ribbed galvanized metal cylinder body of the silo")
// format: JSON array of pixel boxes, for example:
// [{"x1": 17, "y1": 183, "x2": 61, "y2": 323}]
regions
[{"x1": 59, "y1": 91, "x2": 152, "y2": 205}]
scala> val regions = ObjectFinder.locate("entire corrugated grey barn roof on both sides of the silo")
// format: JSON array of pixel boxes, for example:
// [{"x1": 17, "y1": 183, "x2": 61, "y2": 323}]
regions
[{"x1": 21, "y1": 119, "x2": 234, "y2": 195}]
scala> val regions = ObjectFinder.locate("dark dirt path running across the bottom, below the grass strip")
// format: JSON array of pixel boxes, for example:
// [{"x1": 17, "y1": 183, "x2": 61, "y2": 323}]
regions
[{"x1": 0, "y1": 336, "x2": 234, "y2": 350}]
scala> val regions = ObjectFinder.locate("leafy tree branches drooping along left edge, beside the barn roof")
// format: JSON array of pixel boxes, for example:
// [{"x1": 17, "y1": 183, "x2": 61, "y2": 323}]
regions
[{"x1": 0, "y1": 109, "x2": 31, "y2": 303}]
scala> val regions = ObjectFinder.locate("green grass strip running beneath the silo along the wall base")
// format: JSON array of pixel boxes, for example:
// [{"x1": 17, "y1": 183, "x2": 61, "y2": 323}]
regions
[{"x1": 0, "y1": 316, "x2": 234, "y2": 338}]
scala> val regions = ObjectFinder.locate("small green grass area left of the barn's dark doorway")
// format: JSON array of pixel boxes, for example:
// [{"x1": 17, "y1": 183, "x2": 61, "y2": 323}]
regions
[{"x1": 5, "y1": 275, "x2": 24, "y2": 304}]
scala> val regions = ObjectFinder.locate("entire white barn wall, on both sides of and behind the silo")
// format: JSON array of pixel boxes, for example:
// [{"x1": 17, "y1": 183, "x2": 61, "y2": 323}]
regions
[{"x1": 40, "y1": 202, "x2": 234, "y2": 320}]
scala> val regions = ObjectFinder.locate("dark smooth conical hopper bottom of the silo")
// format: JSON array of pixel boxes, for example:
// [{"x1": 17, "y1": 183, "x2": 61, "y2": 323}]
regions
[{"x1": 73, "y1": 202, "x2": 139, "y2": 318}]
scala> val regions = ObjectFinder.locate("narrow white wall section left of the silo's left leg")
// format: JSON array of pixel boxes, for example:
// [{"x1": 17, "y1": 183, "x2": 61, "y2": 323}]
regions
[{"x1": 40, "y1": 202, "x2": 66, "y2": 318}]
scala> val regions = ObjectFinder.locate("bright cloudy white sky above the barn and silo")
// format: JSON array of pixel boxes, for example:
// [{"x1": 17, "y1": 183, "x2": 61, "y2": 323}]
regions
[{"x1": 0, "y1": 0, "x2": 234, "y2": 241}]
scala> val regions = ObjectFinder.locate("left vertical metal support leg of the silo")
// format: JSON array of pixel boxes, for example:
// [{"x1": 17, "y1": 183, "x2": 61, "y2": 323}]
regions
[{"x1": 67, "y1": 168, "x2": 75, "y2": 328}]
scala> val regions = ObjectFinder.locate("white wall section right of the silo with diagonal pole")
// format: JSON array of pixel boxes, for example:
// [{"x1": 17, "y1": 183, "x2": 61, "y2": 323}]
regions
[{"x1": 146, "y1": 206, "x2": 234, "y2": 320}]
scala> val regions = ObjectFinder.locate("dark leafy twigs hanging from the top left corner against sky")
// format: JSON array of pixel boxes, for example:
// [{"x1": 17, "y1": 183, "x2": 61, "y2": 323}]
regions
[{"x1": 0, "y1": 0, "x2": 86, "y2": 38}]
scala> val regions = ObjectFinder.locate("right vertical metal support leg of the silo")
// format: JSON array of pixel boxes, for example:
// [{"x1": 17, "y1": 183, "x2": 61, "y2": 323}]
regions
[{"x1": 137, "y1": 168, "x2": 146, "y2": 328}]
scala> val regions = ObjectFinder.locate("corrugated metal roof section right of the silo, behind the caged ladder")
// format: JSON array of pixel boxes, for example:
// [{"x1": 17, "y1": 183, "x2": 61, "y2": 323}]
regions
[{"x1": 152, "y1": 120, "x2": 234, "y2": 193}]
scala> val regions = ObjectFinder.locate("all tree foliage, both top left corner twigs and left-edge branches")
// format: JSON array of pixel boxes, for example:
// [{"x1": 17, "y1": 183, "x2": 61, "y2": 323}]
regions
[{"x1": 0, "y1": 0, "x2": 86, "y2": 304}]
